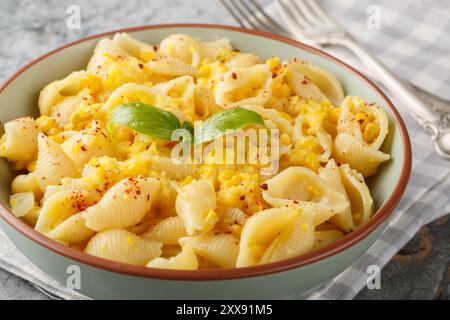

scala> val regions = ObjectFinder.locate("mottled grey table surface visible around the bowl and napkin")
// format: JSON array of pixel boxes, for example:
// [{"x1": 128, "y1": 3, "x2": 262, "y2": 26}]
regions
[{"x1": 0, "y1": 0, "x2": 450, "y2": 299}]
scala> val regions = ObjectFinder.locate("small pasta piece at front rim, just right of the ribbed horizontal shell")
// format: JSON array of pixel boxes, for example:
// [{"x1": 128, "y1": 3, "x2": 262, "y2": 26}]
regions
[{"x1": 147, "y1": 246, "x2": 198, "y2": 270}]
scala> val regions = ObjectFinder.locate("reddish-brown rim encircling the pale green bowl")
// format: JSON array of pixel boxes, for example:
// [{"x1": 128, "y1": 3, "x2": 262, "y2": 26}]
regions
[{"x1": 0, "y1": 24, "x2": 412, "y2": 280}]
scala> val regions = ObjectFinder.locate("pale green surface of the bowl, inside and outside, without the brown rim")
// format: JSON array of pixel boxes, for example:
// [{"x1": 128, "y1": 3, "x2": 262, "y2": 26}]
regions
[{"x1": 0, "y1": 26, "x2": 410, "y2": 299}]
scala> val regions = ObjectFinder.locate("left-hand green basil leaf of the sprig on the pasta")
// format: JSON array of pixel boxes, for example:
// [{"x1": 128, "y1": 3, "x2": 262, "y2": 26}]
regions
[{"x1": 108, "y1": 102, "x2": 180, "y2": 140}]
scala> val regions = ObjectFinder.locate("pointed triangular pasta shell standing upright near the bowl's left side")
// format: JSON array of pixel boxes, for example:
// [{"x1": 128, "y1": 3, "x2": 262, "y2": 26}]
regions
[{"x1": 34, "y1": 133, "x2": 80, "y2": 191}]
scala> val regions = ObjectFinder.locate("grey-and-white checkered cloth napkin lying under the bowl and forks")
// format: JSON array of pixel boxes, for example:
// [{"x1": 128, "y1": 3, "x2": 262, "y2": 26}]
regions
[{"x1": 0, "y1": 0, "x2": 450, "y2": 299}]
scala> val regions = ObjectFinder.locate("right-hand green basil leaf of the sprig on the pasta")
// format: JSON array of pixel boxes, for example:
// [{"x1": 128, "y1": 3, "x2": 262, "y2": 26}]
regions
[{"x1": 194, "y1": 107, "x2": 265, "y2": 144}]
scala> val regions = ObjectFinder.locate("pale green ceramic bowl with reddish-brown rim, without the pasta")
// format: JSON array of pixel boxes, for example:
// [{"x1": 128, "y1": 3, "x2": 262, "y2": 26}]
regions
[{"x1": 0, "y1": 24, "x2": 411, "y2": 299}]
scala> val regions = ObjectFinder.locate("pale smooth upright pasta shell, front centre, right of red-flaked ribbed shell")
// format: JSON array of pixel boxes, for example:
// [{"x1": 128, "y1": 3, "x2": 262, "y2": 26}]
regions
[{"x1": 175, "y1": 180, "x2": 218, "y2": 235}]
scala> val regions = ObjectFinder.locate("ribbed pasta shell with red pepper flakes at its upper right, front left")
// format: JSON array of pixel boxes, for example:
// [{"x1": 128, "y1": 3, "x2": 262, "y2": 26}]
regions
[{"x1": 83, "y1": 178, "x2": 160, "y2": 231}]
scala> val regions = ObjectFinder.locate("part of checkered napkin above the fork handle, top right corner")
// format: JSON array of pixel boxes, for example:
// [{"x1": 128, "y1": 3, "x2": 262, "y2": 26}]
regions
[{"x1": 320, "y1": 0, "x2": 450, "y2": 101}]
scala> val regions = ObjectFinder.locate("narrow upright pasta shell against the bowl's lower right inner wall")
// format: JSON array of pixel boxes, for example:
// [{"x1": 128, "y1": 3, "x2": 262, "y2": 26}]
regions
[{"x1": 339, "y1": 164, "x2": 373, "y2": 227}]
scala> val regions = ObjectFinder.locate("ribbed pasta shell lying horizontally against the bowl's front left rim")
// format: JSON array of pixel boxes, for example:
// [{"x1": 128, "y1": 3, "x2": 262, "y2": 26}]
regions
[{"x1": 84, "y1": 229, "x2": 162, "y2": 266}]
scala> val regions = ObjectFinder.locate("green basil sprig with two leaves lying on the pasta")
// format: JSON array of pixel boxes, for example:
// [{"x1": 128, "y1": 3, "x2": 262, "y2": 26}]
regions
[{"x1": 108, "y1": 102, "x2": 265, "y2": 144}]
